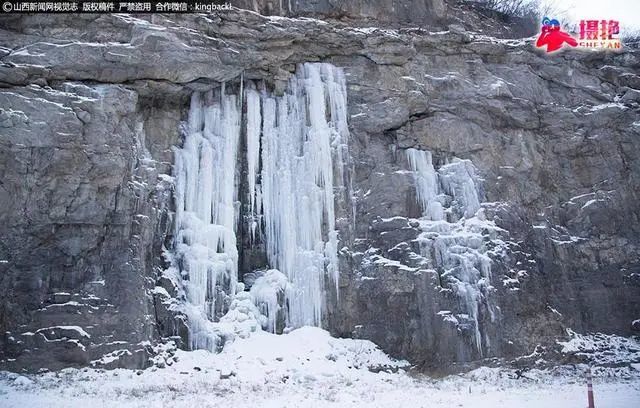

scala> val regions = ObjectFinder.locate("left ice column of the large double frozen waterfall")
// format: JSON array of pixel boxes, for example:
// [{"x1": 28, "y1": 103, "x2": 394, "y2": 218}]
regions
[{"x1": 174, "y1": 87, "x2": 240, "y2": 350}]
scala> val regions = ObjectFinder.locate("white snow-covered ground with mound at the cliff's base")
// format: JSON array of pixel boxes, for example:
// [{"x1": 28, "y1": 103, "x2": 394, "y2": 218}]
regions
[{"x1": 0, "y1": 327, "x2": 640, "y2": 408}]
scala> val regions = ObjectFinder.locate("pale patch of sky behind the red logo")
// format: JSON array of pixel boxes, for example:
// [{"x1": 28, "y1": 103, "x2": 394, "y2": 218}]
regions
[{"x1": 543, "y1": 0, "x2": 640, "y2": 31}]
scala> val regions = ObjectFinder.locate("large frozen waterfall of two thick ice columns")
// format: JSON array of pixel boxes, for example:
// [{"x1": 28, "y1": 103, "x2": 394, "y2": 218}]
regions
[{"x1": 170, "y1": 63, "x2": 349, "y2": 350}]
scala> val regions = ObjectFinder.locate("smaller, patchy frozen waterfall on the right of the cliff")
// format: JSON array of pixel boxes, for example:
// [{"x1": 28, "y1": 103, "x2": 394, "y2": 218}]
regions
[{"x1": 406, "y1": 149, "x2": 497, "y2": 355}]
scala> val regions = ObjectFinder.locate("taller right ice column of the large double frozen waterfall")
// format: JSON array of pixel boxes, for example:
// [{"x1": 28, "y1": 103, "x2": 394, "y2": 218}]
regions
[{"x1": 261, "y1": 64, "x2": 348, "y2": 327}]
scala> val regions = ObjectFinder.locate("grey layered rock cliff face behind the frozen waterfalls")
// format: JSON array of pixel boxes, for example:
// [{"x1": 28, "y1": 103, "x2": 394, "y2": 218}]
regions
[{"x1": 0, "y1": 6, "x2": 640, "y2": 369}]
